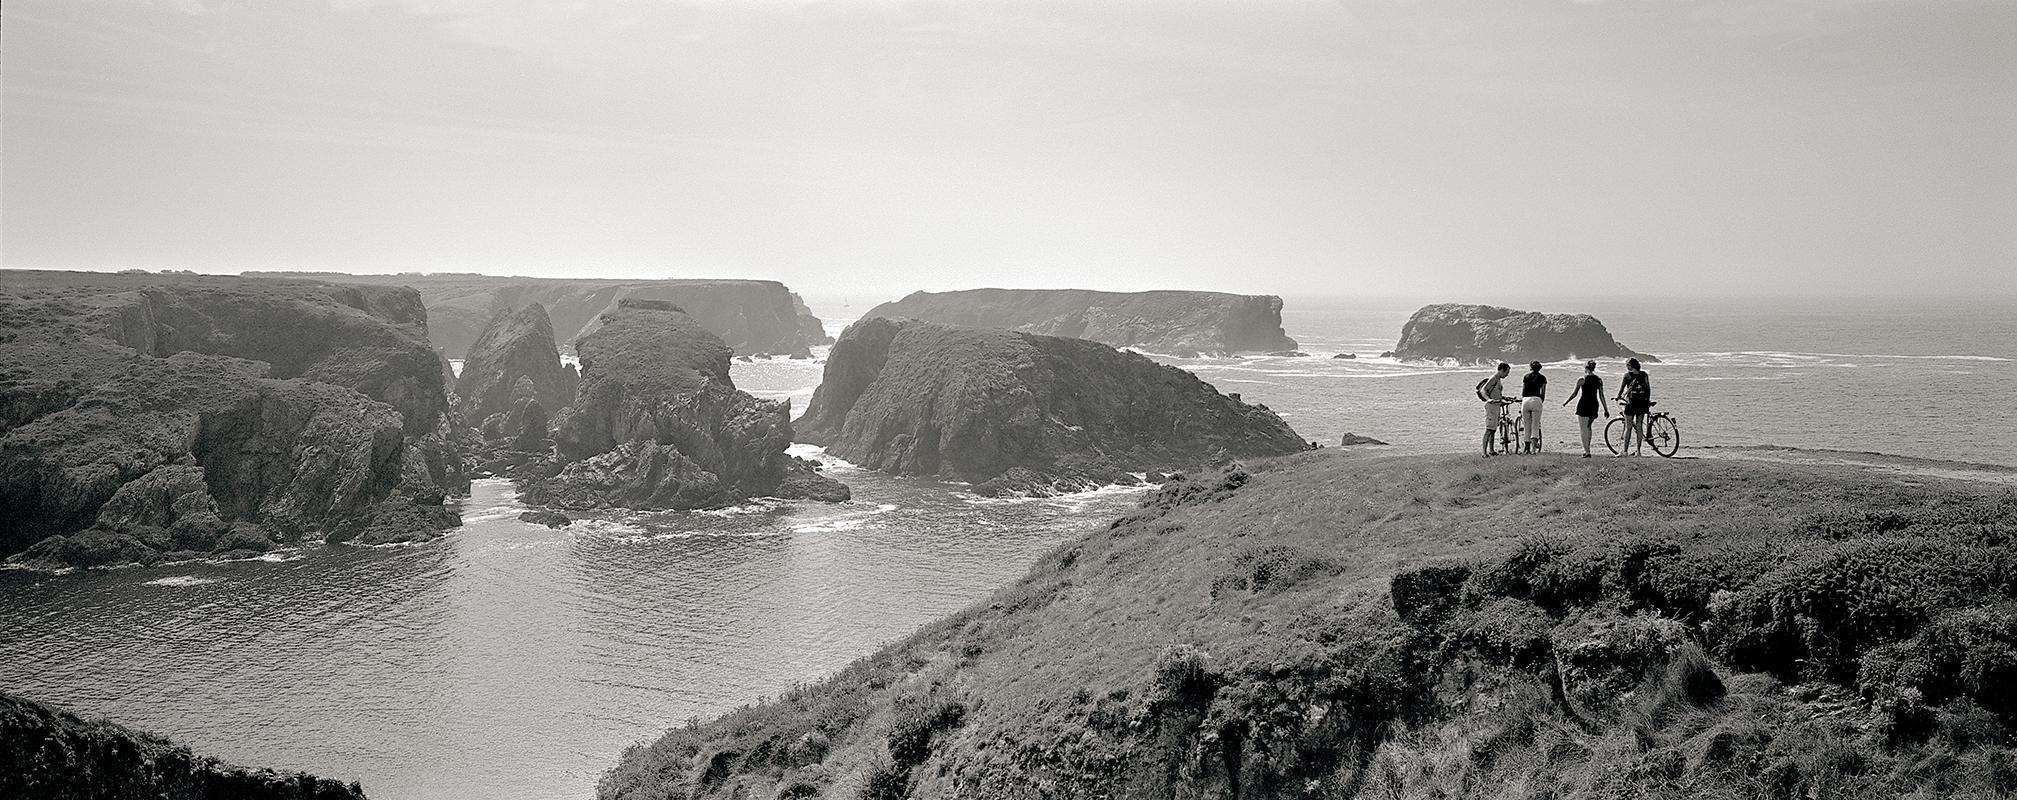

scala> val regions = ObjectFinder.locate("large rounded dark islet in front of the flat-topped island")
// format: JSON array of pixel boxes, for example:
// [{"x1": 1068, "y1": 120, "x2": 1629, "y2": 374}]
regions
[{"x1": 799, "y1": 318, "x2": 1307, "y2": 494}]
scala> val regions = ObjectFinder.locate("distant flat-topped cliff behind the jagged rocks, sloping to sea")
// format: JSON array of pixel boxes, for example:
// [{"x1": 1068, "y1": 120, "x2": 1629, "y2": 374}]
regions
[{"x1": 254, "y1": 272, "x2": 831, "y2": 359}]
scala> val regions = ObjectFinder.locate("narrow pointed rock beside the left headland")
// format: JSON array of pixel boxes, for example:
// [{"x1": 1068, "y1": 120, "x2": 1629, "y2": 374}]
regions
[{"x1": 456, "y1": 302, "x2": 573, "y2": 427}]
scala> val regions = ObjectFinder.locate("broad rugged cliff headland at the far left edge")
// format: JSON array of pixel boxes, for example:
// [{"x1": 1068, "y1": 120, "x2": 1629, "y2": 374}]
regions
[{"x1": 0, "y1": 272, "x2": 466, "y2": 566}]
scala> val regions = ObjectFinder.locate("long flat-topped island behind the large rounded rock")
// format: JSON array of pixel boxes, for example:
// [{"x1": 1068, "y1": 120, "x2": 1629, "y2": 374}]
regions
[{"x1": 863, "y1": 288, "x2": 1295, "y2": 357}]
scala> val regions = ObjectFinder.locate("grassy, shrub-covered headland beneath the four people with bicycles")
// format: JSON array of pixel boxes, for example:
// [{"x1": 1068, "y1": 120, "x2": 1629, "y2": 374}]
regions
[{"x1": 601, "y1": 451, "x2": 2017, "y2": 800}]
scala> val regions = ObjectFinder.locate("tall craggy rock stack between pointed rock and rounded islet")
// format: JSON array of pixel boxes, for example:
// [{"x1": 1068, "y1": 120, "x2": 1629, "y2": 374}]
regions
[{"x1": 524, "y1": 298, "x2": 847, "y2": 510}]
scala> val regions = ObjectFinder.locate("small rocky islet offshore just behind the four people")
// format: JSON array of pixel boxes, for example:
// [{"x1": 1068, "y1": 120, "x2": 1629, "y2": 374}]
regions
[{"x1": 1394, "y1": 302, "x2": 1660, "y2": 363}]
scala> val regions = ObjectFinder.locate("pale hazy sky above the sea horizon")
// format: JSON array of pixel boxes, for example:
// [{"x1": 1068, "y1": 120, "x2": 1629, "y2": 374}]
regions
[{"x1": 0, "y1": 0, "x2": 2017, "y2": 298}]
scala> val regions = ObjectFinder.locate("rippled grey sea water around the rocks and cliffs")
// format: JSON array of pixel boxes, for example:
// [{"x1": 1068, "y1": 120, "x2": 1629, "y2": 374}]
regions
[{"x1": 0, "y1": 298, "x2": 2017, "y2": 800}]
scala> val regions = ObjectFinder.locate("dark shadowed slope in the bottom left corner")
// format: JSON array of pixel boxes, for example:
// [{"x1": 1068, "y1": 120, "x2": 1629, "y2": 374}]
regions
[{"x1": 0, "y1": 693, "x2": 365, "y2": 800}]
